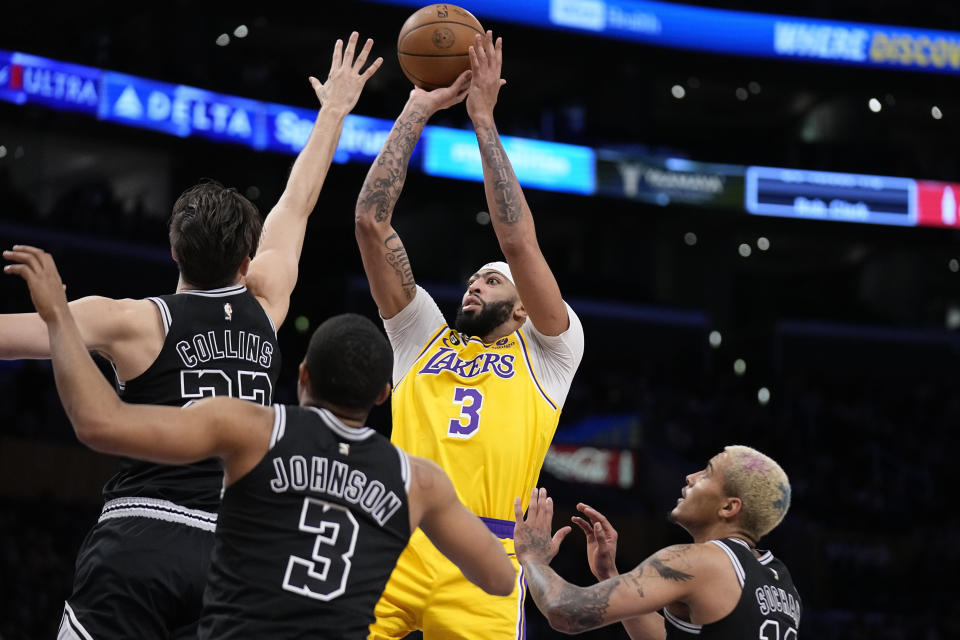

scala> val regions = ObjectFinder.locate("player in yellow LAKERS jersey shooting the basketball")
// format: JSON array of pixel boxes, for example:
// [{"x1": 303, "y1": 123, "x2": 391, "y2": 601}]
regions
[{"x1": 356, "y1": 32, "x2": 583, "y2": 639}]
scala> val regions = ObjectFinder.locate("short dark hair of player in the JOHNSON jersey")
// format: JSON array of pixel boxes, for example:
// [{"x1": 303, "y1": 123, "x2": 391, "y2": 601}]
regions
[{"x1": 305, "y1": 313, "x2": 393, "y2": 411}]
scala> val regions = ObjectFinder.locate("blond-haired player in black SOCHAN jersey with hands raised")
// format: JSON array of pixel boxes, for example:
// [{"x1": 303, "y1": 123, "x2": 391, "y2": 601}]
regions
[{"x1": 515, "y1": 445, "x2": 801, "y2": 640}]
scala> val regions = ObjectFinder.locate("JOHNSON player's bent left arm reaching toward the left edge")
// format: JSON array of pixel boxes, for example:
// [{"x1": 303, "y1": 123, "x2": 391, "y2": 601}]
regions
[{"x1": 3, "y1": 245, "x2": 272, "y2": 476}]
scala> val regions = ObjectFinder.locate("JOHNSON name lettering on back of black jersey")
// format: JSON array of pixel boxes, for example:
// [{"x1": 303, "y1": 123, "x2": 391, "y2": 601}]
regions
[{"x1": 270, "y1": 456, "x2": 403, "y2": 527}]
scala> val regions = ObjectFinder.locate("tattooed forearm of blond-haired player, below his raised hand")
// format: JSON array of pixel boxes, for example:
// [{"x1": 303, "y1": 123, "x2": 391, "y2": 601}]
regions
[{"x1": 524, "y1": 563, "x2": 617, "y2": 633}]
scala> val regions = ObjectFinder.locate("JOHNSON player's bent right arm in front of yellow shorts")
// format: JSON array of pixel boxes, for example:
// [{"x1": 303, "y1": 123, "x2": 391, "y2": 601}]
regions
[{"x1": 410, "y1": 456, "x2": 516, "y2": 596}]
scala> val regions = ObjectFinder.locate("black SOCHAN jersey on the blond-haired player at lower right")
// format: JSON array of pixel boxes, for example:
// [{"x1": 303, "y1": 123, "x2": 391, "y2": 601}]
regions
[{"x1": 664, "y1": 538, "x2": 800, "y2": 640}]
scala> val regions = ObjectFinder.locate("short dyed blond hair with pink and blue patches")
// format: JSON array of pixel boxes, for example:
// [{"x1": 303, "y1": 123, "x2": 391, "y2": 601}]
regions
[{"x1": 723, "y1": 445, "x2": 791, "y2": 540}]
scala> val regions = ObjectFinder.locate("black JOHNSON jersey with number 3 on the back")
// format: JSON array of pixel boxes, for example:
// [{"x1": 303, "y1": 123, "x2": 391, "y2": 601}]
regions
[{"x1": 200, "y1": 405, "x2": 410, "y2": 640}]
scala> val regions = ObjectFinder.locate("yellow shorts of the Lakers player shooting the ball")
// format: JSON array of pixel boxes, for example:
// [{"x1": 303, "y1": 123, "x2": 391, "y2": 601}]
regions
[{"x1": 368, "y1": 522, "x2": 527, "y2": 640}]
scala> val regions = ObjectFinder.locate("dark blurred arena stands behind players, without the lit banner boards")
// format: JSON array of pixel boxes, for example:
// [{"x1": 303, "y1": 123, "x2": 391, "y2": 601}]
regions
[{"x1": 0, "y1": 0, "x2": 960, "y2": 640}]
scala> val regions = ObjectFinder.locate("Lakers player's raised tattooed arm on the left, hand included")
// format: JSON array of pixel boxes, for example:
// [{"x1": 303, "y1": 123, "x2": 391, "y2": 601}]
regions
[{"x1": 355, "y1": 72, "x2": 470, "y2": 318}]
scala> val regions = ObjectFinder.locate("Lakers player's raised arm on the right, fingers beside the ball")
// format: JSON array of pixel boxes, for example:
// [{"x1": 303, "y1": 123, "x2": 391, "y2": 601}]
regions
[{"x1": 467, "y1": 31, "x2": 570, "y2": 336}]
